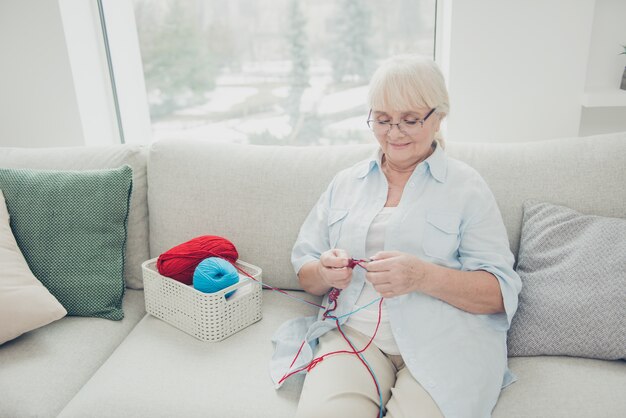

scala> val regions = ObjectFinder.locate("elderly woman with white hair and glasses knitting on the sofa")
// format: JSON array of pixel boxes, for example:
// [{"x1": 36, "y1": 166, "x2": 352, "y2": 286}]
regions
[{"x1": 272, "y1": 56, "x2": 521, "y2": 418}]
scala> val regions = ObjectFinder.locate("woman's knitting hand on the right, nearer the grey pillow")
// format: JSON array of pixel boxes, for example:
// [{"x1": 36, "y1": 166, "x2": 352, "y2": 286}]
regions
[{"x1": 364, "y1": 251, "x2": 429, "y2": 298}]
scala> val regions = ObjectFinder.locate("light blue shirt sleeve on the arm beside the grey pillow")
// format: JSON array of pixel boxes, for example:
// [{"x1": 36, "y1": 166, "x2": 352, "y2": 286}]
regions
[{"x1": 459, "y1": 179, "x2": 522, "y2": 331}]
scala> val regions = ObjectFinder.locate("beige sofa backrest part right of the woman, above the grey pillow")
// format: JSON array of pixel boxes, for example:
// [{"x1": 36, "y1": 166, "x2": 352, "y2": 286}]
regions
[{"x1": 448, "y1": 132, "x2": 626, "y2": 259}]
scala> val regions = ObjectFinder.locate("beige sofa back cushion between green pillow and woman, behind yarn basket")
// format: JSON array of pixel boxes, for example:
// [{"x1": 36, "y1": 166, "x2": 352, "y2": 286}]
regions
[{"x1": 148, "y1": 140, "x2": 374, "y2": 289}]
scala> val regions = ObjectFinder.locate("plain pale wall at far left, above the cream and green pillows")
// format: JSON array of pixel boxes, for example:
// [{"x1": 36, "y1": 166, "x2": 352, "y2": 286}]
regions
[{"x1": 0, "y1": 0, "x2": 84, "y2": 147}]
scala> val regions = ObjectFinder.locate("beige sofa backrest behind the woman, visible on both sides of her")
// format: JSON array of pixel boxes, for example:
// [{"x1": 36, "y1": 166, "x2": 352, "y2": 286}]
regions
[{"x1": 148, "y1": 133, "x2": 626, "y2": 289}]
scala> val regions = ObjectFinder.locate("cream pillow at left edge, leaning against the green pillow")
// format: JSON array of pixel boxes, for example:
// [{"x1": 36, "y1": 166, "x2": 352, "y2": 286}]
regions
[{"x1": 0, "y1": 190, "x2": 67, "y2": 344}]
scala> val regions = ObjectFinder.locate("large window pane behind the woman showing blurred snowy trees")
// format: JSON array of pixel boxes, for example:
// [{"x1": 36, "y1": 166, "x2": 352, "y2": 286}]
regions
[{"x1": 134, "y1": 0, "x2": 436, "y2": 145}]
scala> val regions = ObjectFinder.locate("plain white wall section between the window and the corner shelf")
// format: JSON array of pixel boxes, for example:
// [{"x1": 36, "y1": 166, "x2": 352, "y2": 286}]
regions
[{"x1": 442, "y1": 0, "x2": 595, "y2": 142}]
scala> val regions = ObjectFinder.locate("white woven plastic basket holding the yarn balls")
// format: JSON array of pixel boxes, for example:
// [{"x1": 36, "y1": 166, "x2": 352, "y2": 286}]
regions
[{"x1": 141, "y1": 258, "x2": 262, "y2": 342}]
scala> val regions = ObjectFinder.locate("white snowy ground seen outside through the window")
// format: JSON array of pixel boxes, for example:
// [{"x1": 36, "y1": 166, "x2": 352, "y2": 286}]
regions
[{"x1": 152, "y1": 62, "x2": 371, "y2": 144}]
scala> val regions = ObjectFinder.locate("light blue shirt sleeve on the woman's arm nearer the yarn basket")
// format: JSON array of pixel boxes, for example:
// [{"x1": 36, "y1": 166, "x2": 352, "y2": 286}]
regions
[{"x1": 291, "y1": 180, "x2": 334, "y2": 274}]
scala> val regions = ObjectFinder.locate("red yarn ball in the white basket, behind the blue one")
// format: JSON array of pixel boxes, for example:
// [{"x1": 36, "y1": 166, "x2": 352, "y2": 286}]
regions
[{"x1": 157, "y1": 235, "x2": 239, "y2": 285}]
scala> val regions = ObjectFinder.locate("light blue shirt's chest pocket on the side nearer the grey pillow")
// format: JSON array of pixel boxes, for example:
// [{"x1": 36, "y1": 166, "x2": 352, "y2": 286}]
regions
[{"x1": 422, "y1": 212, "x2": 461, "y2": 259}]
